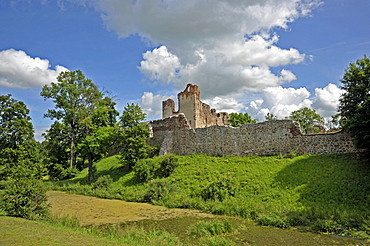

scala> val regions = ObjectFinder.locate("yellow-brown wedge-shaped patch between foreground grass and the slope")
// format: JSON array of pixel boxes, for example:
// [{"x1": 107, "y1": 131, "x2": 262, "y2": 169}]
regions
[{"x1": 47, "y1": 191, "x2": 216, "y2": 224}]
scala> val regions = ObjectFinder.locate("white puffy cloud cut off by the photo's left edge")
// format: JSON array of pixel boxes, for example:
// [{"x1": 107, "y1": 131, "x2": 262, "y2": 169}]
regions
[{"x1": 0, "y1": 49, "x2": 68, "y2": 89}]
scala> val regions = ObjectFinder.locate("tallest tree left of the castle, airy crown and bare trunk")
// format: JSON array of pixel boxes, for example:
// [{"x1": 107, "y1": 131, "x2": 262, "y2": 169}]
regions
[{"x1": 40, "y1": 70, "x2": 118, "y2": 173}]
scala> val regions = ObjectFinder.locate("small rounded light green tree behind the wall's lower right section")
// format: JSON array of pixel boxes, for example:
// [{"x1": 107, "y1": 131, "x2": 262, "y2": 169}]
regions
[{"x1": 289, "y1": 107, "x2": 324, "y2": 134}]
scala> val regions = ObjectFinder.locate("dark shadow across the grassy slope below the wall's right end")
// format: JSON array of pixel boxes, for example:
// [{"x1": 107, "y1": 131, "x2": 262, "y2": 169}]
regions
[{"x1": 275, "y1": 155, "x2": 370, "y2": 223}]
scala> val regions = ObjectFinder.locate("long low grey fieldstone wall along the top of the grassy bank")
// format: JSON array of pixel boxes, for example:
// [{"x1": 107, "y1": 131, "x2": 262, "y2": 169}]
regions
[{"x1": 151, "y1": 117, "x2": 357, "y2": 156}]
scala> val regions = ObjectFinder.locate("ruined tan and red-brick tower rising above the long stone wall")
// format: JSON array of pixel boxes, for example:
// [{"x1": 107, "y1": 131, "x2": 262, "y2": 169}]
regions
[{"x1": 162, "y1": 84, "x2": 229, "y2": 129}]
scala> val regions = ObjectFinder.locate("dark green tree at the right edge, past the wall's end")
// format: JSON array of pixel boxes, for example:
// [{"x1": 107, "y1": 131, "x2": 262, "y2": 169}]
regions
[{"x1": 339, "y1": 55, "x2": 370, "y2": 150}]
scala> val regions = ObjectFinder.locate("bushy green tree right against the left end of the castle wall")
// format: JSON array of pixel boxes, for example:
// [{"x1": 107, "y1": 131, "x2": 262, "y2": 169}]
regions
[{"x1": 119, "y1": 104, "x2": 151, "y2": 168}]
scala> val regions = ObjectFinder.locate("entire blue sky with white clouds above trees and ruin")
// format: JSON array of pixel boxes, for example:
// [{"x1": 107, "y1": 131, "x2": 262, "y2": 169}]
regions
[{"x1": 0, "y1": 0, "x2": 370, "y2": 141}]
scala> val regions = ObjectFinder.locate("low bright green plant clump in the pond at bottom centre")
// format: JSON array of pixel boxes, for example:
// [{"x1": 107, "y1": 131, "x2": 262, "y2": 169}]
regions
[{"x1": 189, "y1": 219, "x2": 234, "y2": 237}]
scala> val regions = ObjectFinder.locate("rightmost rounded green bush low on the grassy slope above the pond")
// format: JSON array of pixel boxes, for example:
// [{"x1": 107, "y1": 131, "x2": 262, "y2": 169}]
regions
[{"x1": 200, "y1": 177, "x2": 237, "y2": 202}]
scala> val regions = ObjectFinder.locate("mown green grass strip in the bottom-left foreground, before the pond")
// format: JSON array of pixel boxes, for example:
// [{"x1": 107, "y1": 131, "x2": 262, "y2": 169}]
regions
[{"x1": 0, "y1": 216, "x2": 180, "y2": 246}]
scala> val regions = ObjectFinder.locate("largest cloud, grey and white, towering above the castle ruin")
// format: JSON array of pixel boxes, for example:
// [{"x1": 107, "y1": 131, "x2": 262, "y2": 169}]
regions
[{"x1": 93, "y1": 0, "x2": 320, "y2": 99}]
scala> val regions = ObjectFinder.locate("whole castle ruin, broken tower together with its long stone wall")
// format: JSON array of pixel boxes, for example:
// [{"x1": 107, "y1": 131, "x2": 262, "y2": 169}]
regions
[{"x1": 148, "y1": 84, "x2": 357, "y2": 156}]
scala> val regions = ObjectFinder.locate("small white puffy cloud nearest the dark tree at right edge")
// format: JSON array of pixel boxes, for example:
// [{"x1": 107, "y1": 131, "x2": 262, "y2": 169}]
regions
[{"x1": 312, "y1": 83, "x2": 344, "y2": 118}]
